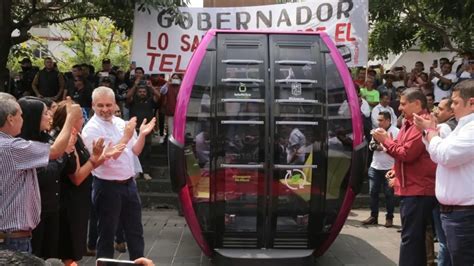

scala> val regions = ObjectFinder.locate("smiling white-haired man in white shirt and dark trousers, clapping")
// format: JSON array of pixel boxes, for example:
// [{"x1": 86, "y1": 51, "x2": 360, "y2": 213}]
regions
[{"x1": 82, "y1": 87, "x2": 155, "y2": 260}]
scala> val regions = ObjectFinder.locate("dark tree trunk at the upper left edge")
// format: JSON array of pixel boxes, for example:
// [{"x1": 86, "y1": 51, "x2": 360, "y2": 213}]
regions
[{"x1": 0, "y1": 0, "x2": 12, "y2": 91}]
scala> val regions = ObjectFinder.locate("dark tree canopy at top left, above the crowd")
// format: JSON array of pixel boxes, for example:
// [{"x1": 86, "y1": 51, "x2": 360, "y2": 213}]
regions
[{"x1": 0, "y1": 0, "x2": 187, "y2": 91}]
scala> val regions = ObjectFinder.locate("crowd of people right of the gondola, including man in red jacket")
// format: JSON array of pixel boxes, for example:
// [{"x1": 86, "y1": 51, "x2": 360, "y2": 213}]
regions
[{"x1": 354, "y1": 54, "x2": 474, "y2": 265}]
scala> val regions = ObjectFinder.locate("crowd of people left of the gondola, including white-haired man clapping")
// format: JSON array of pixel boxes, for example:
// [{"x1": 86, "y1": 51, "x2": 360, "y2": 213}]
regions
[{"x1": 0, "y1": 58, "x2": 182, "y2": 265}]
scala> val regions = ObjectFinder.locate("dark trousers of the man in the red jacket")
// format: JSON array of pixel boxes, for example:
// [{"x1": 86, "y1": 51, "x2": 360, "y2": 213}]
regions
[{"x1": 399, "y1": 196, "x2": 436, "y2": 266}]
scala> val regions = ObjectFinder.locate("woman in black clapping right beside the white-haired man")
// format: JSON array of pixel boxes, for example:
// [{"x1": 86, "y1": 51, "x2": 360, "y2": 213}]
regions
[{"x1": 52, "y1": 101, "x2": 125, "y2": 265}]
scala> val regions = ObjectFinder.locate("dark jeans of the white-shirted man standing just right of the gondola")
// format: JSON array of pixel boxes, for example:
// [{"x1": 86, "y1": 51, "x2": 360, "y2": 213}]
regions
[{"x1": 369, "y1": 167, "x2": 395, "y2": 219}]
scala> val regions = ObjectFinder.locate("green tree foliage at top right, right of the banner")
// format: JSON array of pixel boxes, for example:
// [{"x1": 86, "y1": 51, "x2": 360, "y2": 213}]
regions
[{"x1": 369, "y1": 0, "x2": 474, "y2": 58}]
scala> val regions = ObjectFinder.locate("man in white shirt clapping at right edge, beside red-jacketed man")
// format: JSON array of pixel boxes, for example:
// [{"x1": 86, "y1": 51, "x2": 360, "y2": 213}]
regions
[{"x1": 415, "y1": 80, "x2": 474, "y2": 265}]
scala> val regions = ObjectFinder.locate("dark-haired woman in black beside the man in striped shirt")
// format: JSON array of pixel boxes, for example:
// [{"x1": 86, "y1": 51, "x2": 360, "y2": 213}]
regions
[{"x1": 18, "y1": 98, "x2": 76, "y2": 259}]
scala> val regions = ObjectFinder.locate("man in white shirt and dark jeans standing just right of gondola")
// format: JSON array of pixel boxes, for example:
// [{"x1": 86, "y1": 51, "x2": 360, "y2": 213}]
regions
[{"x1": 362, "y1": 110, "x2": 399, "y2": 227}]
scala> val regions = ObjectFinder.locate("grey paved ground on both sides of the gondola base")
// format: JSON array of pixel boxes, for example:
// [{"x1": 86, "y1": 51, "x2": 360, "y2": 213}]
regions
[{"x1": 79, "y1": 209, "x2": 408, "y2": 266}]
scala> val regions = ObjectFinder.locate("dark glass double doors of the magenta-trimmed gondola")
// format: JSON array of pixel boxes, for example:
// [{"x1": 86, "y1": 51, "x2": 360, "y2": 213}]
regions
[{"x1": 211, "y1": 34, "x2": 325, "y2": 248}]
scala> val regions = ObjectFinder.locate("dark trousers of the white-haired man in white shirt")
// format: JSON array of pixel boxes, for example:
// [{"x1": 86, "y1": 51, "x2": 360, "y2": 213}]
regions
[{"x1": 92, "y1": 178, "x2": 145, "y2": 260}]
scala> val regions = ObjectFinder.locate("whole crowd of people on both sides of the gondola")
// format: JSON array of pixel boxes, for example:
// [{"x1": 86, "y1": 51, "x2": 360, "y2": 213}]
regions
[{"x1": 0, "y1": 52, "x2": 474, "y2": 265}]
